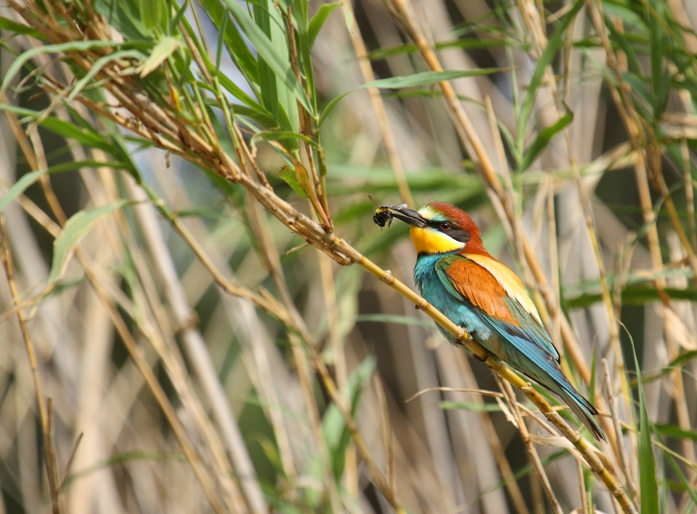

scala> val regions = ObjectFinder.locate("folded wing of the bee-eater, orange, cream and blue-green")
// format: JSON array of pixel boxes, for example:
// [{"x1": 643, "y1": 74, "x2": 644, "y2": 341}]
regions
[{"x1": 436, "y1": 254, "x2": 559, "y2": 361}]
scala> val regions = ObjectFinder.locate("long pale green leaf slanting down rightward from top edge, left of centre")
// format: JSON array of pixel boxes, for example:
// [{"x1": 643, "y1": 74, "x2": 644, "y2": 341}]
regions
[{"x1": 223, "y1": 0, "x2": 314, "y2": 115}]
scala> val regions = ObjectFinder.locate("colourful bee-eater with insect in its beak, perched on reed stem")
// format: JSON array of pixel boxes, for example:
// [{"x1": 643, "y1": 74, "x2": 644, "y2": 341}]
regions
[{"x1": 375, "y1": 202, "x2": 605, "y2": 439}]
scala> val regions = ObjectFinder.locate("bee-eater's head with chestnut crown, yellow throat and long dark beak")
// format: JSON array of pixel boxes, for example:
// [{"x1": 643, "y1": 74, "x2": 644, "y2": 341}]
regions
[{"x1": 390, "y1": 202, "x2": 488, "y2": 255}]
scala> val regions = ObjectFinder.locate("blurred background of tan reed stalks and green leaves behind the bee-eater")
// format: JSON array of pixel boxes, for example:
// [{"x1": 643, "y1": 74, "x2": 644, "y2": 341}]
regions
[{"x1": 0, "y1": 0, "x2": 697, "y2": 514}]
